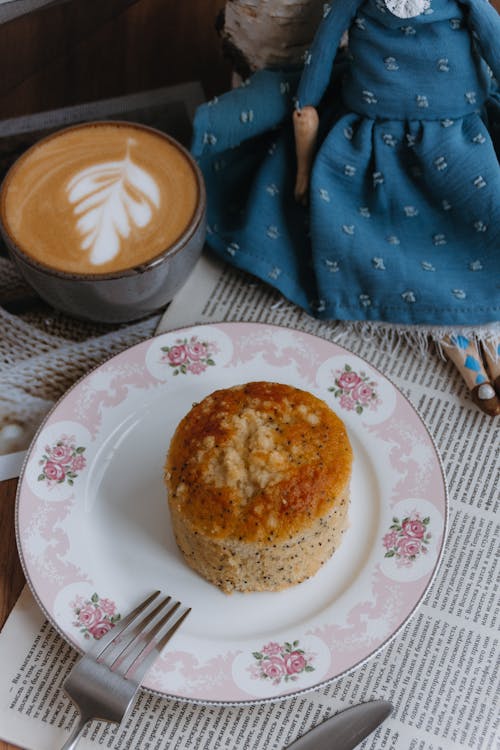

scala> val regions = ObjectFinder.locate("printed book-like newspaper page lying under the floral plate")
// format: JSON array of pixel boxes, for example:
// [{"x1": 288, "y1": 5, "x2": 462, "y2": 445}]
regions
[{"x1": 0, "y1": 256, "x2": 500, "y2": 750}]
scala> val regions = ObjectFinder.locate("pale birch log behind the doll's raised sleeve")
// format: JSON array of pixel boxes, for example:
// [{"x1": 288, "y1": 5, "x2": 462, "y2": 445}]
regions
[{"x1": 219, "y1": 0, "x2": 326, "y2": 77}]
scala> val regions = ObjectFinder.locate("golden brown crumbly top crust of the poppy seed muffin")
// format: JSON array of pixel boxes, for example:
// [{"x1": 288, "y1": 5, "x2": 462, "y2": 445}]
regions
[{"x1": 165, "y1": 382, "x2": 352, "y2": 543}]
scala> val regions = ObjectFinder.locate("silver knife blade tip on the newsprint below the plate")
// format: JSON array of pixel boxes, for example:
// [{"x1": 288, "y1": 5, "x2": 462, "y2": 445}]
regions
[{"x1": 285, "y1": 700, "x2": 392, "y2": 750}]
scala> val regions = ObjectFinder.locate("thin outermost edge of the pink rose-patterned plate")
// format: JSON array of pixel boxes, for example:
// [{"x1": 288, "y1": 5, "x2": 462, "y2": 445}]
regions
[{"x1": 14, "y1": 320, "x2": 450, "y2": 707}]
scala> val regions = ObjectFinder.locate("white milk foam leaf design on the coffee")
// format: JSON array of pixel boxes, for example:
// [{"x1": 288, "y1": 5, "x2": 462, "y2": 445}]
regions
[{"x1": 66, "y1": 145, "x2": 160, "y2": 266}]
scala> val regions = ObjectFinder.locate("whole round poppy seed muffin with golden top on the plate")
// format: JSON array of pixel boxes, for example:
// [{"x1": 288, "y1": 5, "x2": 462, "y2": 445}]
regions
[{"x1": 165, "y1": 382, "x2": 352, "y2": 593}]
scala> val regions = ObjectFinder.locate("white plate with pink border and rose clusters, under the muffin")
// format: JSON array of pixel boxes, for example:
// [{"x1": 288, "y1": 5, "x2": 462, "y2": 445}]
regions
[{"x1": 17, "y1": 323, "x2": 447, "y2": 703}]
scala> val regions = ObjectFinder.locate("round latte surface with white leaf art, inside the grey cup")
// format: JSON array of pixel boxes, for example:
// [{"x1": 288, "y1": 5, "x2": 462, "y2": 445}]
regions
[{"x1": 1, "y1": 122, "x2": 200, "y2": 275}]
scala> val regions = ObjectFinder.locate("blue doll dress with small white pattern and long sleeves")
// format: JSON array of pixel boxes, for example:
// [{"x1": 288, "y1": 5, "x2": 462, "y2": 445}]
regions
[{"x1": 193, "y1": 0, "x2": 500, "y2": 325}]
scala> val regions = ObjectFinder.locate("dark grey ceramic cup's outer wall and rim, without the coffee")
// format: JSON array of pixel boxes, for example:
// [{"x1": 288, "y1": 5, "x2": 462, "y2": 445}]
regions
[{"x1": 0, "y1": 122, "x2": 206, "y2": 323}]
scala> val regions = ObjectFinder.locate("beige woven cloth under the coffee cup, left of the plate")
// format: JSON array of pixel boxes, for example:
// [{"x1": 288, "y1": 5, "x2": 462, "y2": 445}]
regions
[{"x1": 0, "y1": 255, "x2": 159, "y2": 454}]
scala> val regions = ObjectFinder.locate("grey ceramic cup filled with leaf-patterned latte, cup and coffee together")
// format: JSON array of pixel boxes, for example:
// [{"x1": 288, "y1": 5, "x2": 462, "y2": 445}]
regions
[{"x1": 0, "y1": 121, "x2": 206, "y2": 323}]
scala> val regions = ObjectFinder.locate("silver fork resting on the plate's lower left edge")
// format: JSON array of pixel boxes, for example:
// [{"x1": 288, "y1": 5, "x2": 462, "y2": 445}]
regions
[{"x1": 62, "y1": 591, "x2": 191, "y2": 750}]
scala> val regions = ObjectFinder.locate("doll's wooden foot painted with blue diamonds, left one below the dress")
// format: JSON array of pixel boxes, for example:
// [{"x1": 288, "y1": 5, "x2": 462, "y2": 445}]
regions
[{"x1": 442, "y1": 336, "x2": 500, "y2": 417}]
